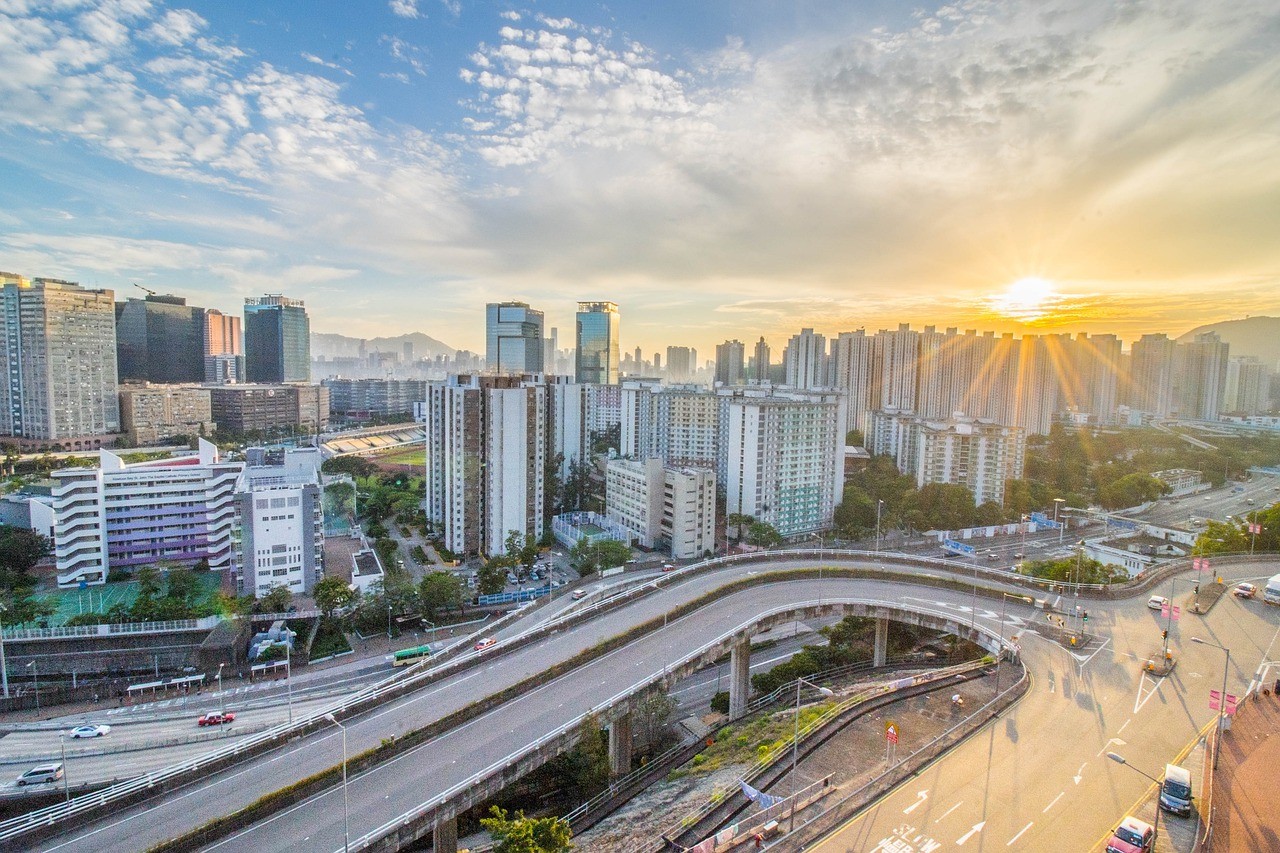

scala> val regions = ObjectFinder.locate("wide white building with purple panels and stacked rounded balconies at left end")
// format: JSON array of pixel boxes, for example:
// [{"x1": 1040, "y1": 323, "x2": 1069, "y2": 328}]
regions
[{"x1": 52, "y1": 439, "x2": 244, "y2": 588}]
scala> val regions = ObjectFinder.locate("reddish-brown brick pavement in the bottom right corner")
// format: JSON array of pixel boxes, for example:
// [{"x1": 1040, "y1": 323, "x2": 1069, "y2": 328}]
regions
[{"x1": 1208, "y1": 690, "x2": 1280, "y2": 853}]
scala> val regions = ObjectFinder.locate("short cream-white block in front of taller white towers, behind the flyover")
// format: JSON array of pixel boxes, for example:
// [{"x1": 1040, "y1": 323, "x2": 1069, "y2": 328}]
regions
[{"x1": 605, "y1": 457, "x2": 716, "y2": 560}]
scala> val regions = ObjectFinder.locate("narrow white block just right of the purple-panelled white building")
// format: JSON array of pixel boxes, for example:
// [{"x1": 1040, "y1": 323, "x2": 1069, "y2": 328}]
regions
[{"x1": 237, "y1": 447, "x2": 324, "y2": 598}]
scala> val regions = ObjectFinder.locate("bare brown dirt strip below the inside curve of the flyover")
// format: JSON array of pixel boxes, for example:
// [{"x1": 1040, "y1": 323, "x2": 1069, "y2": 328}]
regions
[{"x1": 573, "y1": 674, "x2": 1007, "y2": 853}]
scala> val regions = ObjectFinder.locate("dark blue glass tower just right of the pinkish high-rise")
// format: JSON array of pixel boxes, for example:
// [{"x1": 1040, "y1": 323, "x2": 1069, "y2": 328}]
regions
[{"x1": 244, "y1": 293, "x2": 311, "y2": 382}]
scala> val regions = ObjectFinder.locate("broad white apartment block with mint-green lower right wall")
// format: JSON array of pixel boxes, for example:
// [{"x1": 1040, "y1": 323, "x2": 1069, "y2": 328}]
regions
[{"x1": 717, "y1": 388, "x2": 845, "y2": 537}]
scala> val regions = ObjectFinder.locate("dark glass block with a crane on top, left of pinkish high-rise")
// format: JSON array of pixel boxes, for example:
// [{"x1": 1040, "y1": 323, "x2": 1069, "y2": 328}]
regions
[{"x1": 115, "y1": 293, "x2": 205, "y2": 384}]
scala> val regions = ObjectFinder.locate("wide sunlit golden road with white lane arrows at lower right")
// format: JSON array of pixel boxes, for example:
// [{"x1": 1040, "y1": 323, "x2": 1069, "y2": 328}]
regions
[{"x1": 809, "y1": 566, "x2": 1280, "y2": 853}]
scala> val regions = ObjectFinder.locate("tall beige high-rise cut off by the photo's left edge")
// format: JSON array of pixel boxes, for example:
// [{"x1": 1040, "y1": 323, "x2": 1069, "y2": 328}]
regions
[{"x1": 0, "y1": 273, "x2": 120, "y2": 450}]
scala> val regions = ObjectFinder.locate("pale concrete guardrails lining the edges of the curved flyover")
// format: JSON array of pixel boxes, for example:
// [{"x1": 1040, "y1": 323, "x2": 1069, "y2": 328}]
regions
[{"x1": 0, "y1": 548, "x2": 1259, "y2": 841}]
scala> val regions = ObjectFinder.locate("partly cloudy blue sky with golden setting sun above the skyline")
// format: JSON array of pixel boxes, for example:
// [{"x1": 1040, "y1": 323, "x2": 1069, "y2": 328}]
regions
[{"x1": 0, "y1": 0, "x2": 1280, "y2": 357}]
